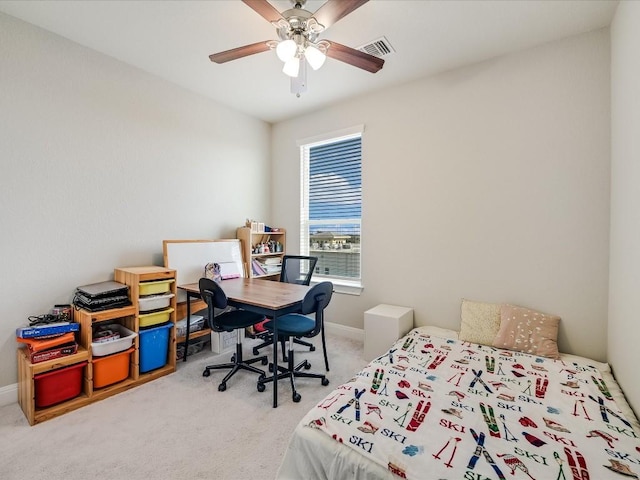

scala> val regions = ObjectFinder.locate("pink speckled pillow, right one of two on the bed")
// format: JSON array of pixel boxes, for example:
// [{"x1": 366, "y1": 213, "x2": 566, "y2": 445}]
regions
[{"x1": 493, "y1": 305, "x2": 560, "y2": 359}]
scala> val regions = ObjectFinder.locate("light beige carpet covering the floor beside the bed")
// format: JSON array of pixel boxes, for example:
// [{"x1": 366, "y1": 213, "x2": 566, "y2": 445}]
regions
[{"x1": 0, "y1": 333, "x2": 367, "y2": 480}]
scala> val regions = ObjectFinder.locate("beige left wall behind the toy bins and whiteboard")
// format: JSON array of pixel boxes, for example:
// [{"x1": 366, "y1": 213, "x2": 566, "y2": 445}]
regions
[{"x1": 0, "y1": 14, "x2": 271, "y2": 388}]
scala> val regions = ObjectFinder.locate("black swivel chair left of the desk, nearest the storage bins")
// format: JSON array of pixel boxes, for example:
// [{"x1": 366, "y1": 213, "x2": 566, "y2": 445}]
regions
[{"x1": 198, "y1": 278, "x2": 269, "y2": 392}]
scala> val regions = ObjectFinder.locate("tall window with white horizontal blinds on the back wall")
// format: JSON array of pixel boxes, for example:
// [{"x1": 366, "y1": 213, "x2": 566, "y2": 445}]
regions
[{"x1": 299, "y1": 127, "x2": 362, "y2": 287}]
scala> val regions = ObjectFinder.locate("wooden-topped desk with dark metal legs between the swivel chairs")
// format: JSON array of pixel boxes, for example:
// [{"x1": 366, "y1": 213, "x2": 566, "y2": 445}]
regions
[{"x1": 178, "y1": 278, "x2": 311, "y2": 408}]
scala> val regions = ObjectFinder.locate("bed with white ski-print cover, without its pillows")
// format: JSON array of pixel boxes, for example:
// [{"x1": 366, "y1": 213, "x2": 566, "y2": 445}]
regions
[{"x1": 278, "y1": 302, "x2": 640, "y2": 480}]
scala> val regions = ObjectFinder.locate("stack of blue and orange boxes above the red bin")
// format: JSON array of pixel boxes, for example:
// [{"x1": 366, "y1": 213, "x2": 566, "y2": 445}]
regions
[{"x1": 16, "y1": 322, "x2": 80, "y2": 363}]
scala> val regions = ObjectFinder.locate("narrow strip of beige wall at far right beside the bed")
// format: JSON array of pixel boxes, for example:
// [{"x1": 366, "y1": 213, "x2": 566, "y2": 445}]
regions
[{"x1": 608, "y1": 2, "x2": 640, "y2": 414}]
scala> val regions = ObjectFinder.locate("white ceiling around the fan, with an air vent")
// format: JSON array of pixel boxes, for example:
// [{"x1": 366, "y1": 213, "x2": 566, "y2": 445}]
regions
[{"x1": 0, "y1": 0, "x2": 618, "y2": 122}]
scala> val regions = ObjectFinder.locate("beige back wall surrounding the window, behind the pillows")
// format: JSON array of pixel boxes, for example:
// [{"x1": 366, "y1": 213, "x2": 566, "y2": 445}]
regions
[{"x1": 272, "y1": 29, "x2": 610, "y2": 360}]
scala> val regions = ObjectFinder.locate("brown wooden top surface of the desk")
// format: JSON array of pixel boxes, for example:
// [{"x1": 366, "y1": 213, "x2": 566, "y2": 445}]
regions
[{"x1": 178, "y1": 278, "x2": 311, "y2": 310}]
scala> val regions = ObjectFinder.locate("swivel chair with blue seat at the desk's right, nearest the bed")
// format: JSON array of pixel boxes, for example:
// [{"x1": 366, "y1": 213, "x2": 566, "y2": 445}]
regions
[{"x1": 257, "y1": 282, "x2": 333, "y2": 402}]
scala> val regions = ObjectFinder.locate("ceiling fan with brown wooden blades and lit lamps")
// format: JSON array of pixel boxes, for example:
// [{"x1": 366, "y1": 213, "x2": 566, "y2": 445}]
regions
[{"x1": 209, "y1": 0, "x2": 384, "y2": 96}]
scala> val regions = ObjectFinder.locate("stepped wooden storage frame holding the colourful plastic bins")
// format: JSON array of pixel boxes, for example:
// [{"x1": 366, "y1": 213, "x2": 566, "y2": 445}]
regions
[{"x1": 17, "y1": 266, "x2": 176, "y2": 425}]
